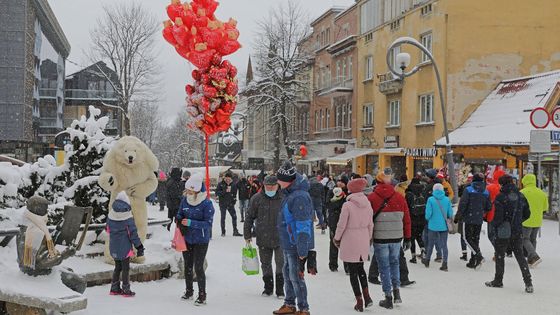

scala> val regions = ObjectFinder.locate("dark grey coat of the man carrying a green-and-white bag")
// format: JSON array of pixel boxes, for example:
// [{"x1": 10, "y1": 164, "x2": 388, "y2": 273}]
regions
[{"x1": 243, "y1": 190, "x2": 284, "y2": 248}]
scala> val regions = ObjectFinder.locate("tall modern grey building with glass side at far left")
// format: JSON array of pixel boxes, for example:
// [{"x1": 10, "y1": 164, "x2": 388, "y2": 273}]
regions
[{"x1": 0, "y1": 0, "x2": 70, "y2": 161}]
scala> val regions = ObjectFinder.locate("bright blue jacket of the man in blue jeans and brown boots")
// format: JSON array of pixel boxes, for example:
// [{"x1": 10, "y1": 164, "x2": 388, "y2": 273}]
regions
[{"x1": 278, "y1": 174, "x2": 315, "y2": 257}]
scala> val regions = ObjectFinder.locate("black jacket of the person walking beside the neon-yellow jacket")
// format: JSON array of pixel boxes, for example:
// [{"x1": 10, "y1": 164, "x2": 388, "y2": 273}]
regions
[{"x1": 491, "y1": 184, "x2": 531, "y2": 238}]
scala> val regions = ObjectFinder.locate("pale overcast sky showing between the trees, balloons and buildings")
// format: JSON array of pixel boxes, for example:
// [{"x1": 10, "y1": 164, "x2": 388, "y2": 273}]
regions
[{"x1": 48, "y1": 0, "x2": 354, "y2": 121}]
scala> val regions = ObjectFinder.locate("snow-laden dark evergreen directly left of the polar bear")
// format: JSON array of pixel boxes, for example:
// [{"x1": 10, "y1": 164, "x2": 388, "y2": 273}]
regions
[{"x1": 64, "y1": 106, "x2": 115, "y2": 223}]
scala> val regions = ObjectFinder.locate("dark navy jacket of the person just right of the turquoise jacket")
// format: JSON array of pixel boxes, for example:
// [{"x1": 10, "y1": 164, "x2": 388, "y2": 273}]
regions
[{"x1": 455, "y1": 182, "x2": 492, "y2": 225}]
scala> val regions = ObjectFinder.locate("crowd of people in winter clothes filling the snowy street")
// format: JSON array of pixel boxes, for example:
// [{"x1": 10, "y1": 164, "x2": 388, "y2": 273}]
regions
[{"x1": 116, "y1": 161, "x2": 548, "y2": 315}]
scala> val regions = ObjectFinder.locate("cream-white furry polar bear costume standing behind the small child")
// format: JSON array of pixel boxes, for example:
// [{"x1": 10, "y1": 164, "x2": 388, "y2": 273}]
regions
[{"x1": 99, "y1": 136, "x2": 159, "y2": 263}]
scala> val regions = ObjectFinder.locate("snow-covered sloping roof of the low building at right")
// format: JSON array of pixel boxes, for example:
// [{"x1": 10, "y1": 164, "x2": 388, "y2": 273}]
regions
[{"x1": 436, "y1": 70, "x2": 560, "y2": 146}]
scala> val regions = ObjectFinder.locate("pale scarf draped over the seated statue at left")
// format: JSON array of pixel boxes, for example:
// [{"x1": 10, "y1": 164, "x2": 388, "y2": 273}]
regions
[{"x1": 23, "y1": 210, "x2": 58, "y2": 268}]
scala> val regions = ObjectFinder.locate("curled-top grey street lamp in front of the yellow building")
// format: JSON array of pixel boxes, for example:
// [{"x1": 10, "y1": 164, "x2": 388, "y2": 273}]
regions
[{"x1": 387, "y1": 37, "x2": 459, "y2": 203}]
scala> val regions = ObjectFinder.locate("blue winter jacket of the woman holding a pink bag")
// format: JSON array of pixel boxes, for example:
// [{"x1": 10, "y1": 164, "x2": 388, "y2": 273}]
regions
[{"x1": 177, "y1": 198, "x2": 214, "y2": 244}]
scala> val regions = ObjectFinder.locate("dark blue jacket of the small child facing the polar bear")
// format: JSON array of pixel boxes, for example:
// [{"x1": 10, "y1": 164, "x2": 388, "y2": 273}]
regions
[{"x1": 107, "y1": 200, "x2": 142, "y2": 260}]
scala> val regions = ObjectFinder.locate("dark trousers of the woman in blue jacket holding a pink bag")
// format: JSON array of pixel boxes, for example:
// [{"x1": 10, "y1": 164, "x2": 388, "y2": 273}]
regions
[{"x1": 183, "y1": 244, "x2": 208, "y2": 293}]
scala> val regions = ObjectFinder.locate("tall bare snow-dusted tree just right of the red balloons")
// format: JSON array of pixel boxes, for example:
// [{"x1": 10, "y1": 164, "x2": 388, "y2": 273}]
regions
[{"x1": 246, "y1": 1, "x2": 309, "y2": 168}]
